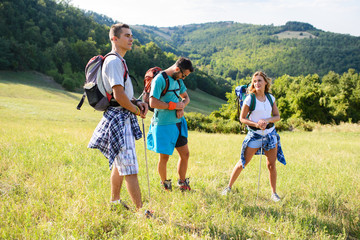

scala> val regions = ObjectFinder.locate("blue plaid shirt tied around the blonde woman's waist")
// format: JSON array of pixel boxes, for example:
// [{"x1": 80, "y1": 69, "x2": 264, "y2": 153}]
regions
[{"x1": 241, "y1": 129, "x2": 286, "y2": 168}]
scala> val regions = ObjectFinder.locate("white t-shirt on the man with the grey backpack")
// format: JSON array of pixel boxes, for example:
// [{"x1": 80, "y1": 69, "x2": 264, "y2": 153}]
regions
[{"x1": 102, "y1": 54, "x2": 134, "y2": 103}]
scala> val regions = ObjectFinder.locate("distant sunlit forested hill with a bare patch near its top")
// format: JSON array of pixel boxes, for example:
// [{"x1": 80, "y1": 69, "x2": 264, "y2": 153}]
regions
[{"x1": 131, "y1": 22, "x2": 360, "y2": 82}]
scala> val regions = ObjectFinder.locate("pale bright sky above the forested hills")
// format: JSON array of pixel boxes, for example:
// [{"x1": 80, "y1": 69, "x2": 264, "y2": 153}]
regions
[{"x1": 70, "y1": 0, "x2": 360, "y2": 37}]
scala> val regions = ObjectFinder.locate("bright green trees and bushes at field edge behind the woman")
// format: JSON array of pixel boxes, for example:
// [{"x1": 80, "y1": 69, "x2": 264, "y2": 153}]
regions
[{"x1": 187, "y1": 69, "x2": 360, "y2": 133}]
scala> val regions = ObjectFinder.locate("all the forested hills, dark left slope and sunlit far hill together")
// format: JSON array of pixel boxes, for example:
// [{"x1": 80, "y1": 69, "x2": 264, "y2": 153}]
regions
[{"x1": 0, "y1": 0, "x2": 360, "y2": 102}]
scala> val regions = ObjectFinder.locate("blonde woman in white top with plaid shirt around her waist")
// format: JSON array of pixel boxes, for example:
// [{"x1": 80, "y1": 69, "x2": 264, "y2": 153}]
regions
[{"x1": 222, "y1": 71, "x2": 286, "y2": 202}]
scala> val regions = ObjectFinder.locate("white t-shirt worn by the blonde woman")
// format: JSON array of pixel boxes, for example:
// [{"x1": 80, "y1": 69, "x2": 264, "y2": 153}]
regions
[{"x1": 244, "y1": 94, "x2": 275, "y2": 135}]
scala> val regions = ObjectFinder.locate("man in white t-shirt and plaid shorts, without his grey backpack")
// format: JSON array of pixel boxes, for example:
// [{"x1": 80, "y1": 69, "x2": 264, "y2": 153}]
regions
[{"x1": 88, "y1": 24, "x2": 148, "y2": 210}]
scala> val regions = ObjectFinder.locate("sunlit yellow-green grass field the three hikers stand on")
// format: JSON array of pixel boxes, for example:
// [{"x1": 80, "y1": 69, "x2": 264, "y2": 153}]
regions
[{"x1": 0, "y1": 72, "x2": 360, "y2": 240}]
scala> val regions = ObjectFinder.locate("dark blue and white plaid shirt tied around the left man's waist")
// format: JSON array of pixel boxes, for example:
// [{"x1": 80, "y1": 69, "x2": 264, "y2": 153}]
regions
[{"x1": 88, "y1": 107, "x2": 142, "y2": 169}]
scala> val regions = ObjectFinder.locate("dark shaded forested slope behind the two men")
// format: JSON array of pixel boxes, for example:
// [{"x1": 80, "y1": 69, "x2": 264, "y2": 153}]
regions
[{"x1": 0, "y1": 0, "x2": 231, "y2": 99}]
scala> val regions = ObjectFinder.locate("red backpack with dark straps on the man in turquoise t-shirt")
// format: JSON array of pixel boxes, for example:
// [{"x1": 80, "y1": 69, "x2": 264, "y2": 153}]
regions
[{"x1": 142, "y1": 67, "x2": 180, "y2": 112}]
